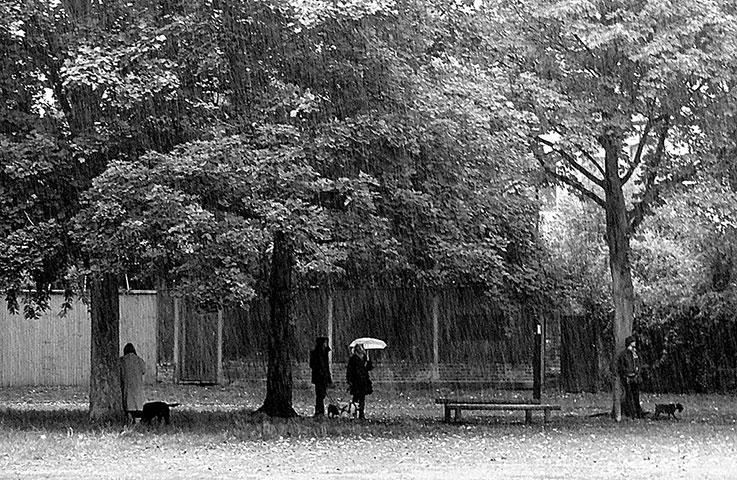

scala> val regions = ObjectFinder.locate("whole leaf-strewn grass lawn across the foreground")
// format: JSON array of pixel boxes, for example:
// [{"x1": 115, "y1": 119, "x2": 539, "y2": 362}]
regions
[{"x1": 0, "y1": 384, "x2": 737, "y2": 480}]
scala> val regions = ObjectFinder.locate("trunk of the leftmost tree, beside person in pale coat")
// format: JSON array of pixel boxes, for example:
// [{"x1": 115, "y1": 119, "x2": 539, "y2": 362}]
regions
[{"x1": 90, "y1": 274, "x2": 124, "y2": 422}]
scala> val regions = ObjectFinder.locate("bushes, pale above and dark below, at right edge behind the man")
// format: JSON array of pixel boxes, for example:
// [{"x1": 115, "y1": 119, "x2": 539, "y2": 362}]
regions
[{"x1": 633, "y1": 178, "x2": 737, "y2": 392}]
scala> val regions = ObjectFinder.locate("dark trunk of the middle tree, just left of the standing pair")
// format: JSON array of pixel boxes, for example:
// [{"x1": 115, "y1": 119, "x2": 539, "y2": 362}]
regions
[{"x1": 257, "y1": 231, "x2": 297, "y2": 418}]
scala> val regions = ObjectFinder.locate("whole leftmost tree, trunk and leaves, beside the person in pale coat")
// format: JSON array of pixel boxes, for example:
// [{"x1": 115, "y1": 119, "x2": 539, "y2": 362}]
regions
[{"x1": 0, "y1": 0, "x2": 213, "y2": 420}]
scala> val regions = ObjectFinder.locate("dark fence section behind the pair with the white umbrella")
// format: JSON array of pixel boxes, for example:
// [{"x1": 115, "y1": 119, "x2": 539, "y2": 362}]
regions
[{"x1": 216, "y1": 289, "x2": 560, "y2": 388}]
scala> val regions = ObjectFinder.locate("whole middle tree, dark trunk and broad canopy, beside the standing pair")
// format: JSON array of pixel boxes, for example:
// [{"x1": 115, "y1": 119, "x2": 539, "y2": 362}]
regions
[{"x1": 79, "y1": 1, "x2": 540, "y2": 416}]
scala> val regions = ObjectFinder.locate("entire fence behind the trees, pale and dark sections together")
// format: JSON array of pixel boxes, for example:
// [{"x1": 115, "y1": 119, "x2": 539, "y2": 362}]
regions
[{"x1": 0, "y1": 289, "x2": 560, "y2": 386}]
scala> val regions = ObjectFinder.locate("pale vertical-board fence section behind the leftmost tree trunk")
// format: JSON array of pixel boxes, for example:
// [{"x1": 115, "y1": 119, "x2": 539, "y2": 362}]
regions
[{"x1": 0, "y1": 291, "x2": 157, "y2": 387}]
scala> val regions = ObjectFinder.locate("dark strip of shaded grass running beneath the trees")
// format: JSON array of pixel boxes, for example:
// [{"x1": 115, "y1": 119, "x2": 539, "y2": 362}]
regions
[{"x1": 0, "y1": 407, "x2": 736, "y2": 441}]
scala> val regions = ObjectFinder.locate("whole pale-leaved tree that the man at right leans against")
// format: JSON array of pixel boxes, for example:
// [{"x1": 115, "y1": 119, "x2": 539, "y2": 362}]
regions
[{"x1": 503, "y1": 0, "x2": 736, "y2": 420}]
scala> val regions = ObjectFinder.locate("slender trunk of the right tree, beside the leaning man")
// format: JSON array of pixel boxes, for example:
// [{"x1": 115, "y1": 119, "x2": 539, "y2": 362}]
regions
[{"x1": 601, "y1": 133, "x2": 634, "y2": 422}]
